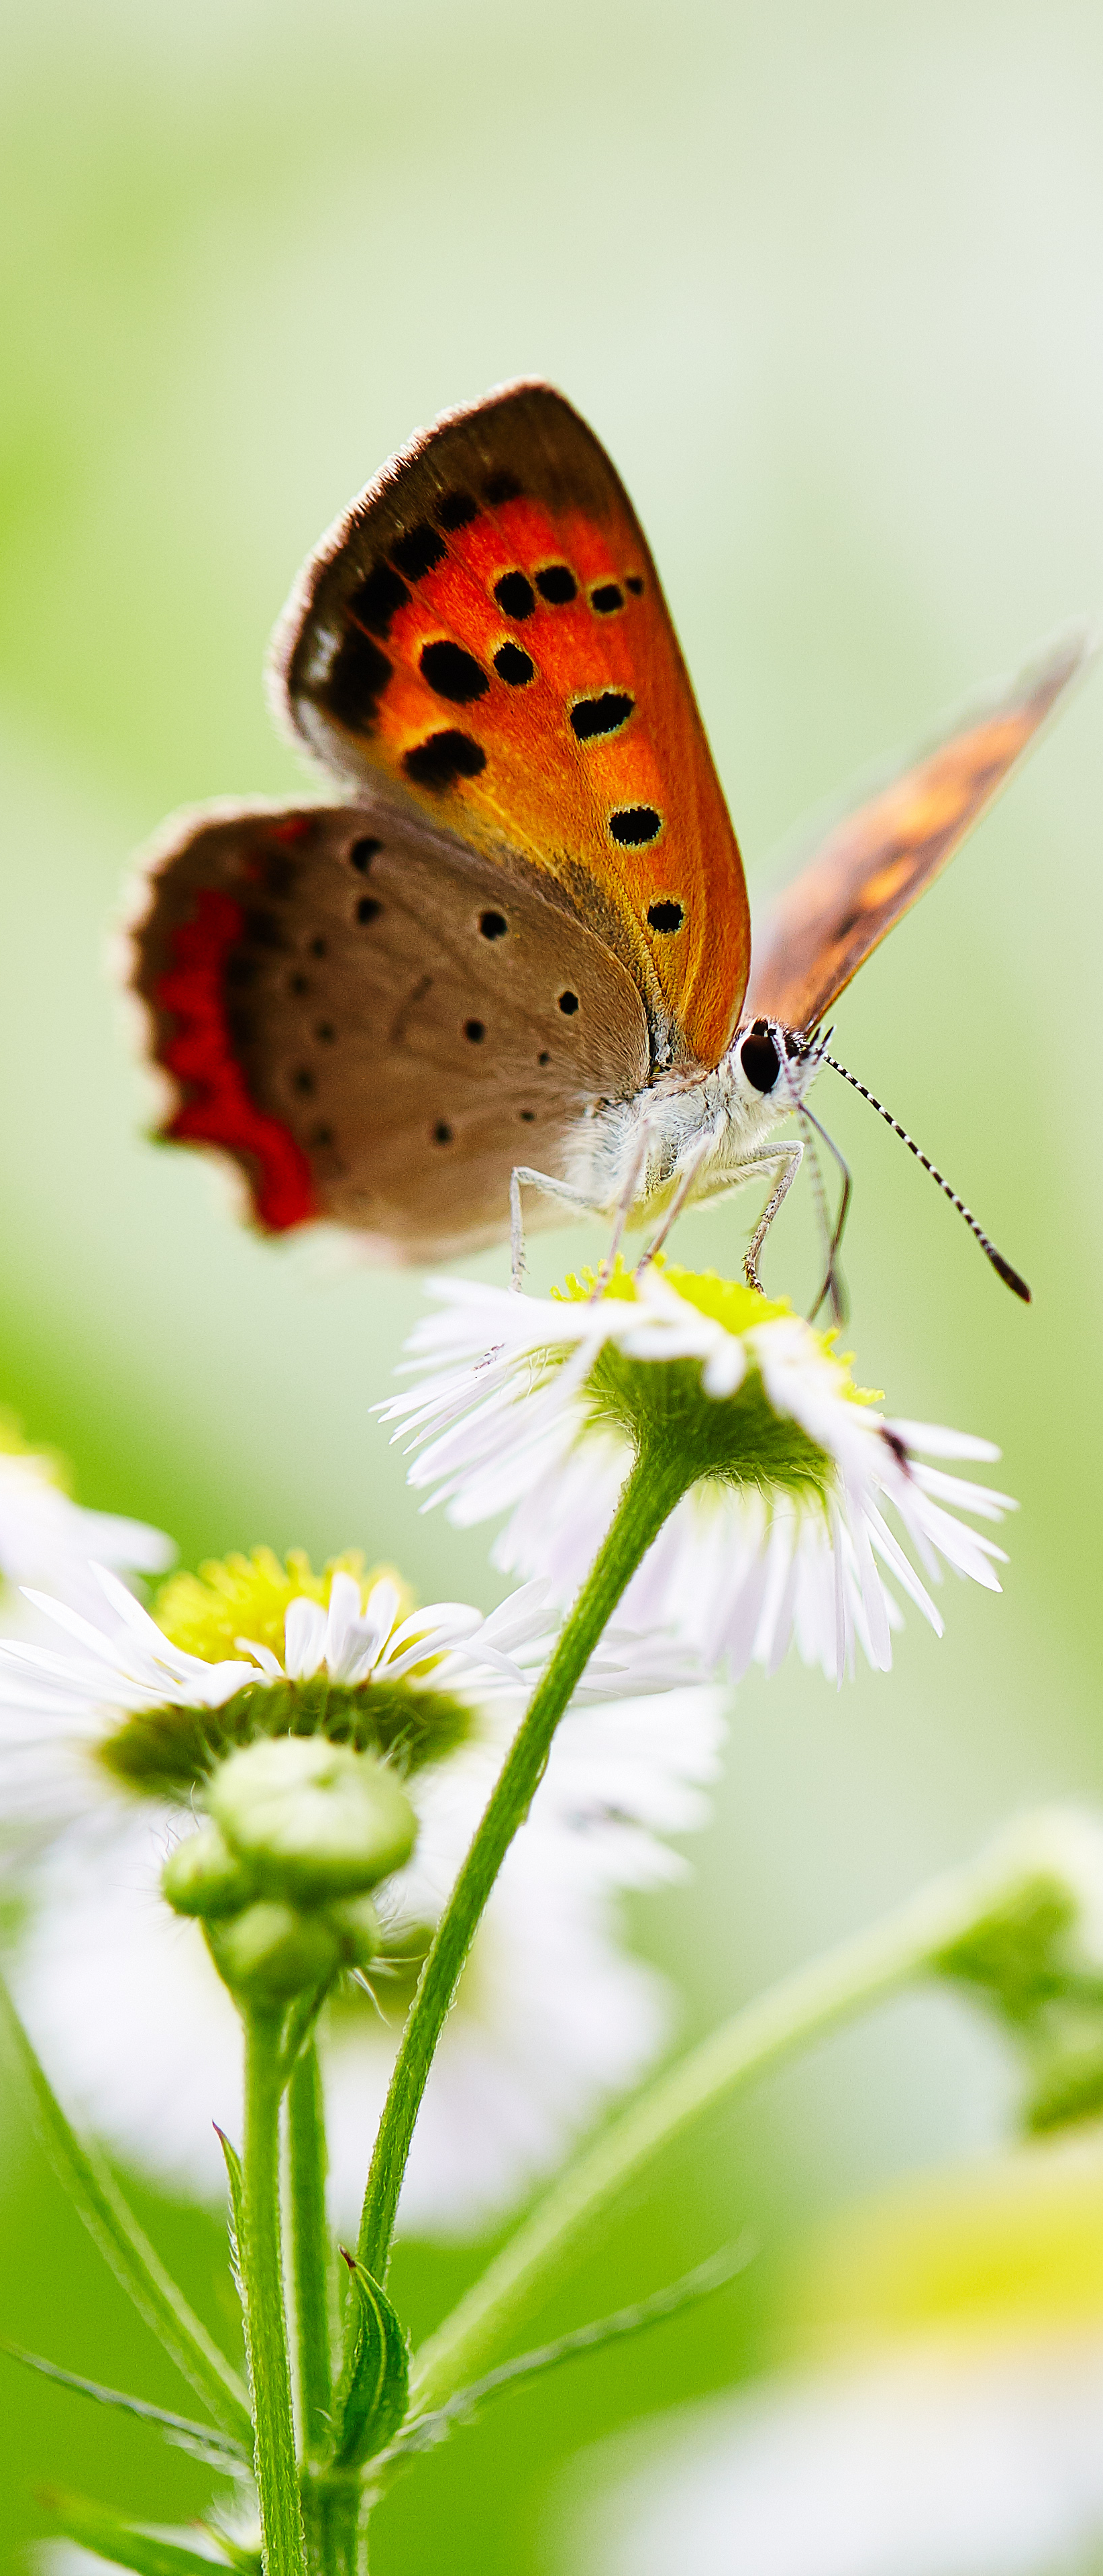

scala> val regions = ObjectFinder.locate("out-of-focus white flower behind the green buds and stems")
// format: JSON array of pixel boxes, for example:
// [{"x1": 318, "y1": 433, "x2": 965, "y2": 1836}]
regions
[{"x1": 13, "y1": 1690, "x2": 722, "y2": 2233}]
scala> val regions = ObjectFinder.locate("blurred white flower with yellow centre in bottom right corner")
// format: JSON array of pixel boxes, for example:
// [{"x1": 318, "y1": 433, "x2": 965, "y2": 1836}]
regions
[{"x1": 572, "y1": 2112, "x2": 1103, "y2": 2576}]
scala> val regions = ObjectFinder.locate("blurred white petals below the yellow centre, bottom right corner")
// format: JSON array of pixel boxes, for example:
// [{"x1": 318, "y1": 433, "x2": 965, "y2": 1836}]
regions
[{"x1": 572, "y1": 2331, "x2": 1103, "y2": 2576}]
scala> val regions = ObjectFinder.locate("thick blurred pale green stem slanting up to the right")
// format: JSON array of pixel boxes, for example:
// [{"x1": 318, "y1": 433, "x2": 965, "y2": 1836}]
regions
[{"x1": 410, "y1": 1855, "x2": 1049, "y2": 2414}]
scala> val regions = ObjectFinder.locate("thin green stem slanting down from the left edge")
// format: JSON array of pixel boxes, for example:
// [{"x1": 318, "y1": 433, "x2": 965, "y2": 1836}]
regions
[{"x1": 0, "y1": 1978, "x2": 252, "y2": 2442}]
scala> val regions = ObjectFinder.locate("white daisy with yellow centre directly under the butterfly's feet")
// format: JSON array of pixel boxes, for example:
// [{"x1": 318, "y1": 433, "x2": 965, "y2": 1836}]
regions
[{"x1": 384, "y1": 1265, "x2": 1013, "y2": 1682}]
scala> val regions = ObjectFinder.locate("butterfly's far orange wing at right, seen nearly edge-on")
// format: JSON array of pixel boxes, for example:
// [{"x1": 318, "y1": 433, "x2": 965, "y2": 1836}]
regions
[{"x1": 745, "y1": 626, "x2": 1098, "y2": 1030}]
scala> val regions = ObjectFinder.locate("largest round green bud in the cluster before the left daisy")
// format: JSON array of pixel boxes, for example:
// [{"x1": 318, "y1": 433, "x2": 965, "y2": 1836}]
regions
[{"x1": 206, "y1": 1736, "x2": 417, "y2": 1904}]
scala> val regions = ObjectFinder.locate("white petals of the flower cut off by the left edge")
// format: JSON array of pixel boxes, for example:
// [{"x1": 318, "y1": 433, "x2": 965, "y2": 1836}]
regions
[{"x1": 0, "y1": 1411, "x2": 175, "y2": 1625}]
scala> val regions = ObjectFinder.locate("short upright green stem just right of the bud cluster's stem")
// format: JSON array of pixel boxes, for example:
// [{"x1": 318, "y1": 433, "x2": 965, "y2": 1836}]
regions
[{"x1": 286, "y1": 2043, "x2": 335, "y2": 2576}]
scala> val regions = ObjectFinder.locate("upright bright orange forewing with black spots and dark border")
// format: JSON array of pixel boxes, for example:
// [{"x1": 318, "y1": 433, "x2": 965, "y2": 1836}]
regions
[{"x1": 276, "y1": 384, "x2": 750, "y2": 1064}]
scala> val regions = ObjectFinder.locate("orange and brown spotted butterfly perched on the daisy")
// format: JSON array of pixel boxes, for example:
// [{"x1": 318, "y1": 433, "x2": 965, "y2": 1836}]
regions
[{"x1": 129, "y1": 381, "x2": 1088, "y2": 1293}]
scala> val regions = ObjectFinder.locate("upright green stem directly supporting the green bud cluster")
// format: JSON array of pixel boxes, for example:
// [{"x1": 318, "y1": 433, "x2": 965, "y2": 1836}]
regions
[{"x1": 240, "y1": 2012, "x2": 304, "y2": 2576}]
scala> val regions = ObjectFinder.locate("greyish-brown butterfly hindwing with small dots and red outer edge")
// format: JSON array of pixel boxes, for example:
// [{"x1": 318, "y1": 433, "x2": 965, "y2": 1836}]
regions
[{"x1": 132, "y1": 798, "x2": 649, "y2": 1260}]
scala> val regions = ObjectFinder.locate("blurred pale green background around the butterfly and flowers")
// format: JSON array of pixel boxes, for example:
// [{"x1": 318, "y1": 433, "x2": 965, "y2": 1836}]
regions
[{"x1": 0, "y1": 0, "x2": 1103, "y2": 2576}]
